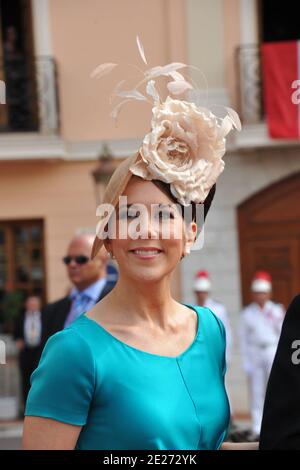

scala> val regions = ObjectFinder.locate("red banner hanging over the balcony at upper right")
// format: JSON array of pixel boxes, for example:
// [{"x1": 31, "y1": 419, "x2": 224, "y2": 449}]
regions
[{"x1": 262, "y1": 41, "x2": 300, "y2": 139}]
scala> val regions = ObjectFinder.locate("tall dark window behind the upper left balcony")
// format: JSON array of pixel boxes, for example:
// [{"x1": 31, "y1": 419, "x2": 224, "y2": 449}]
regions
[{"x1": 0, "y1": 0, "x2": 38, "y2": 132}]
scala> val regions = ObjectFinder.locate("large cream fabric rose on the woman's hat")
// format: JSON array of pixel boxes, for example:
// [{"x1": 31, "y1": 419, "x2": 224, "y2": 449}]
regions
[{"x1": 130, "y1": 97, "x2": 238, "y2": 205}]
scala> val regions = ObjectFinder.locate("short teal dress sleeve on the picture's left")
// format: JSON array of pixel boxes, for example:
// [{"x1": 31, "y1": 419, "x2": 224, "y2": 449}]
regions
[{"x1": 25, "y1": 329, "x2": 95, "y2": 426}]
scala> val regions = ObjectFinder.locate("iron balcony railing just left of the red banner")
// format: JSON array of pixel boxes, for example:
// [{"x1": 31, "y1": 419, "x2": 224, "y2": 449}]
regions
[{"x1": 237, "y1": 45, "x2": 264, "y2": 124}]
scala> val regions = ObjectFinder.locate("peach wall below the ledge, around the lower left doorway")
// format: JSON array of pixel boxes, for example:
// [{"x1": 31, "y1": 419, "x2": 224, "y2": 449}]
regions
[{"x1": 0, "y1": 162, "x2": 96, "y2": 300}]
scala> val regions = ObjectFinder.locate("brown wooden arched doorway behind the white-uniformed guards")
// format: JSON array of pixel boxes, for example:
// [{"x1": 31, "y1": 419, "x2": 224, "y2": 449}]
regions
[{"x1": 238, "y1": 173, "x2": 300, "y2": 307}]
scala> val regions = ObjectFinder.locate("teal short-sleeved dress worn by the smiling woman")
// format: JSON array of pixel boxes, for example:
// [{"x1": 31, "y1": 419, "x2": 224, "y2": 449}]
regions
[{"x1": 25, "y1": 304, "x2": 230, "y2": 450}]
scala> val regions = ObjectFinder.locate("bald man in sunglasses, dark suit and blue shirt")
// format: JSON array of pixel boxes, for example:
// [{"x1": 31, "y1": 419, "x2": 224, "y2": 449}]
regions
[{"x1": 42, "y1": 233, "x2": 115, "y2": 346}]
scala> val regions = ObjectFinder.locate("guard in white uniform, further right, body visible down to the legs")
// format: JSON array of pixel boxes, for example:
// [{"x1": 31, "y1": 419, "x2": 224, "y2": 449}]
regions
[{"x1": 239, "y1": 271, "x2": 285, "y2": 436}]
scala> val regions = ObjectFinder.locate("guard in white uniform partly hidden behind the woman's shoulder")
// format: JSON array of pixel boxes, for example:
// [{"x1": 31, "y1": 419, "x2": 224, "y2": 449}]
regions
[{"x1": 194, "y1": 271, "x2": 232, "y2": 366}]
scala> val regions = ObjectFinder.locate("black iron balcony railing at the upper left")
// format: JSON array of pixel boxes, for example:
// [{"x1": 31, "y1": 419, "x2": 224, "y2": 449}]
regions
[{"x1": 0, "y1": 57, "x2": 59, "y2": 135}]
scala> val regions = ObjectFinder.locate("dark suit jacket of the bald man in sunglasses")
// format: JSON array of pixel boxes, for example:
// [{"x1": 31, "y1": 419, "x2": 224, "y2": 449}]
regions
[{"x1": 42, "y1": 282, "x2": 115, "y2": 347}]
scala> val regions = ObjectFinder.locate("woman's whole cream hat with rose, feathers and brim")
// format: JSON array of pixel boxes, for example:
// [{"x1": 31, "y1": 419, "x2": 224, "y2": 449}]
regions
[{"x1": 91, "y1": 37, "x2": 241, "y2": 258}]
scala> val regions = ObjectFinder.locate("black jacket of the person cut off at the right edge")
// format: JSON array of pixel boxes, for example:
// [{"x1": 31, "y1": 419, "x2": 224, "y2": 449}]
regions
[{"x1": 260, "y1": 295, "x2": 300, "y2": 450}]
